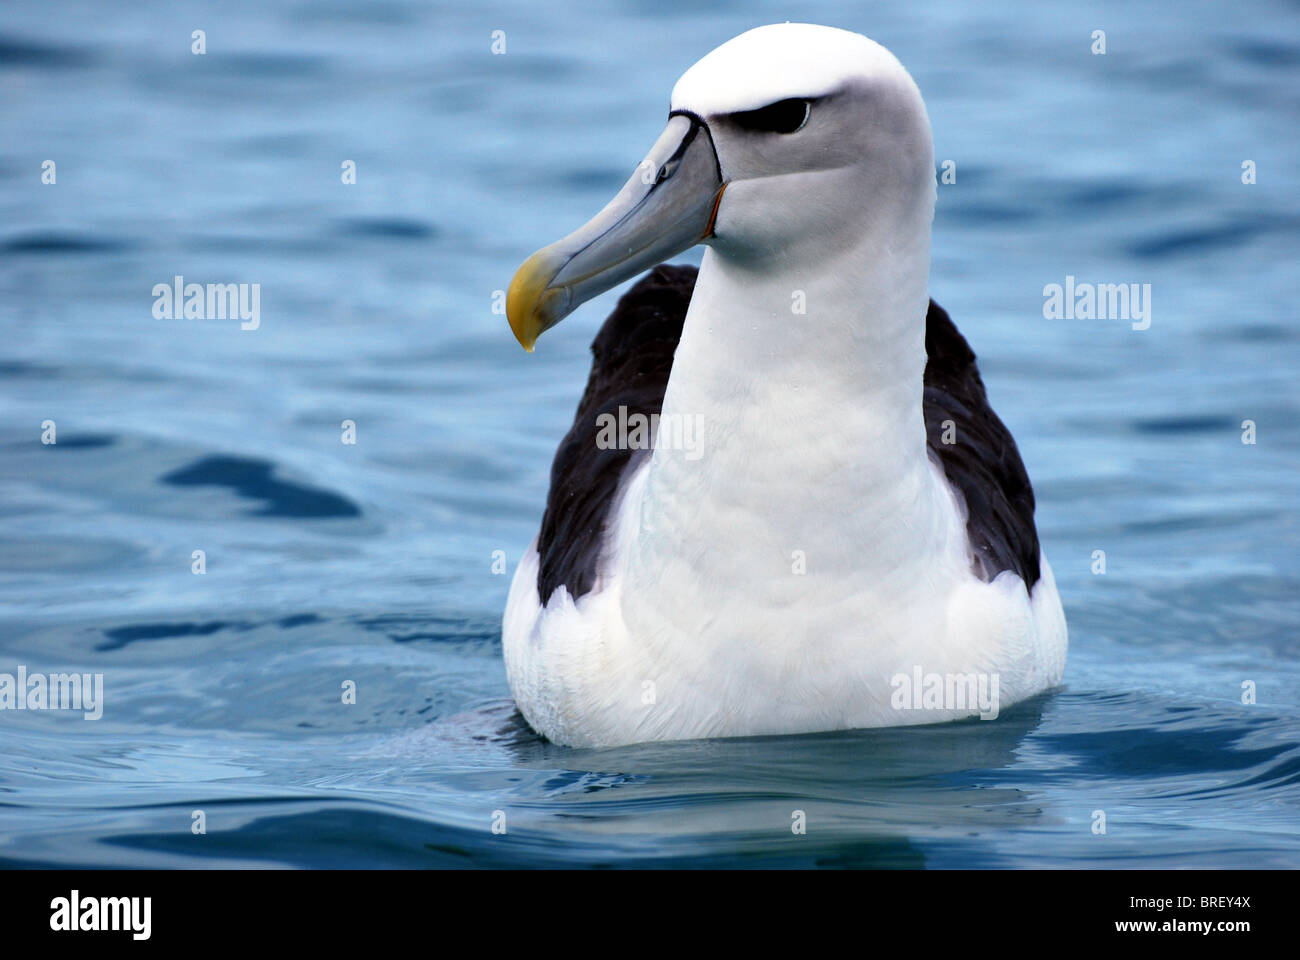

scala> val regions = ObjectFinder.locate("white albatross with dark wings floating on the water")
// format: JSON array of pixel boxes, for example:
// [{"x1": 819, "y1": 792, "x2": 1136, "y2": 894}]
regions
[{"x1": 502, "y1": 23, "x2": 1066, "y2": 747}]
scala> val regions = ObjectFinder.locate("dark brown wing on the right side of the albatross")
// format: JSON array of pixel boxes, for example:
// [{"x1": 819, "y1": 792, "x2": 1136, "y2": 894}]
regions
[{"x1": 924, "y1": 300, "x2": 1039, "y2": 589}]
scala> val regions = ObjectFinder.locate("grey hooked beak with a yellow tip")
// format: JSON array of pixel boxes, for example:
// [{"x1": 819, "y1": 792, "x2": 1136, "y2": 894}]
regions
[{"x1": 506, "y1": 113, "x2": 727, "y2": 353}]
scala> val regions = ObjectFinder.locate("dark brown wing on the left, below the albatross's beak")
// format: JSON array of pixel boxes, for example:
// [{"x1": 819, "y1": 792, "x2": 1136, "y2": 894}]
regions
[{"x1": 537, "y1": 264, "x2": 696, "y2": 606}]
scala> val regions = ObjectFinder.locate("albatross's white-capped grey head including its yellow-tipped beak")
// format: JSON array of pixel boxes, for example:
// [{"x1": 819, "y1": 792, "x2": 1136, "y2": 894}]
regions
[{"x1": 506, "y1": 23, "x2": 935, "y2": 351}]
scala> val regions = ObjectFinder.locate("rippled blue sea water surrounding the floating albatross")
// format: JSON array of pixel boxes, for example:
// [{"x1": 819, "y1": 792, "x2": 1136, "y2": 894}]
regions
[{"x1": 0, "y1": 0, "x2": 1300, "y2": 868}]
